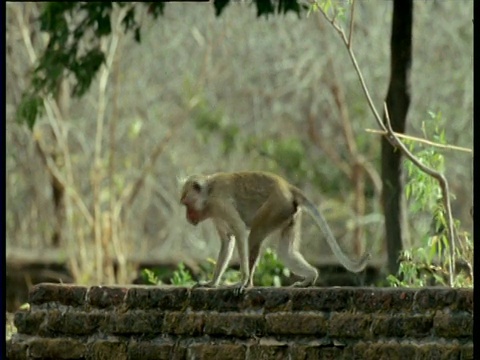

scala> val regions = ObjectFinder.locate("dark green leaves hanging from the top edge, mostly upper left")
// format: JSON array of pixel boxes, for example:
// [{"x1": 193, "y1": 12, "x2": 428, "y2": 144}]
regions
[{"x1": 16, "y1": 0, "x2": 302, "y2": 129}]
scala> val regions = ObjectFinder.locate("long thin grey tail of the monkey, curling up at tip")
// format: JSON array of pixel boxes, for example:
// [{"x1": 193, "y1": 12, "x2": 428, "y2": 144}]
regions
[{"x1": 293, "y1": 188, "x2": 371, "y2": 272}]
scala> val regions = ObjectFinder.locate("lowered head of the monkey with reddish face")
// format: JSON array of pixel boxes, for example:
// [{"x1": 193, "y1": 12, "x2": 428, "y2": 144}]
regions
[{"x1": 180, "y1": 175, "x2": 208, "y2": 225}]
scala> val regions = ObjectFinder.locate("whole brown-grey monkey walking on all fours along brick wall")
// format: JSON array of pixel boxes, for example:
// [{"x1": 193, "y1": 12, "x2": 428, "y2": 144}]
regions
[{"x1": 180, "y1": 171, "x2": 371, "y2": 293}]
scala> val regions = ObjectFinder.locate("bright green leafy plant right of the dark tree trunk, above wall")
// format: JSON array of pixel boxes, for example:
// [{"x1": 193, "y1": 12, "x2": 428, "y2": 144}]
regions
[{"x1": 387, "y1": 112, "x2": 473, "y2": 286}]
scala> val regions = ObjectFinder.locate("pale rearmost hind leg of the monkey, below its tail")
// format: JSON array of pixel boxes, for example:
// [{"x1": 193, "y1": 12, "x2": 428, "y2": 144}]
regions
[{"x1": 278, "y1": 210, "x2": 318, "y2": 287}]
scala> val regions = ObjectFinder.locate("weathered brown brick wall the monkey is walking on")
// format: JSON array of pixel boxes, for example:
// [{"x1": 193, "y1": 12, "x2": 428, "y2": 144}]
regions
[{"x1": 7, "y1": 284, "x2": 473, "y2": 360}]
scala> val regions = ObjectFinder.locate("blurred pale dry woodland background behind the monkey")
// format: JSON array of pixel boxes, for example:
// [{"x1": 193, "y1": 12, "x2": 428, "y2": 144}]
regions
[{"x1": 6, "y1": 0, "x2": 473, "y2": 311}]
